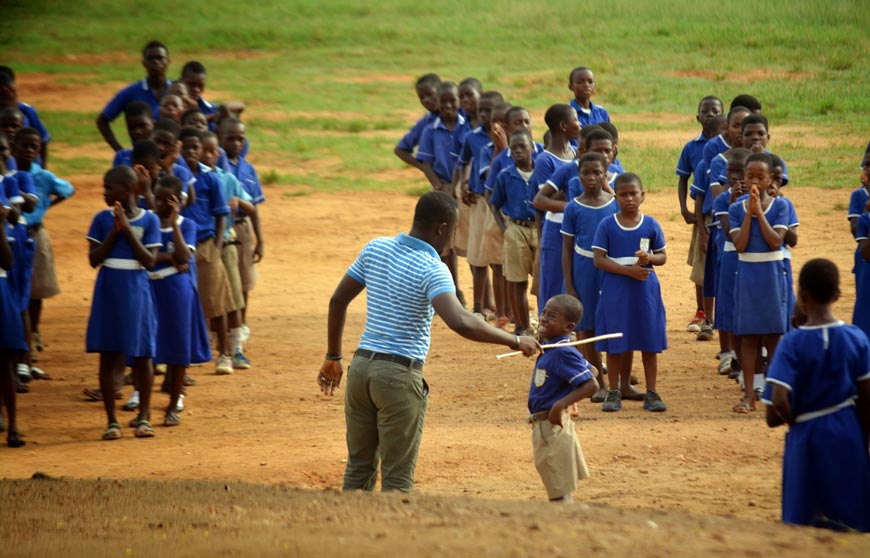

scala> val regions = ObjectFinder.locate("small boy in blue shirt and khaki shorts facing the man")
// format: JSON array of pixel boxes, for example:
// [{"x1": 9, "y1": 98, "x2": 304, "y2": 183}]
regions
[{"x1": 528, "y1": 295, "x2": 598, "y2": 502}]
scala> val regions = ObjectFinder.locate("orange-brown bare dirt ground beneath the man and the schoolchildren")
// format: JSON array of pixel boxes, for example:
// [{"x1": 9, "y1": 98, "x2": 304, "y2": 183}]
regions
[{"x1": 0, "y1": 76, "x2": 870, "y2": 557}]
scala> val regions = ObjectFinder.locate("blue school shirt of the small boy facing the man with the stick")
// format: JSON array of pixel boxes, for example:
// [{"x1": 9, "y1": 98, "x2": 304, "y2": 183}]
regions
[{"x1": 529, "y1": 336, "x2": 595, "y2": 414}]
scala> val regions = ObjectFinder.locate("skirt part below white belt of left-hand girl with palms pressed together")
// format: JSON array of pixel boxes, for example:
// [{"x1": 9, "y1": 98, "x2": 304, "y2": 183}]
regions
[{"x1": 85, "y1": 267, "x2": 157, "y2": 358}]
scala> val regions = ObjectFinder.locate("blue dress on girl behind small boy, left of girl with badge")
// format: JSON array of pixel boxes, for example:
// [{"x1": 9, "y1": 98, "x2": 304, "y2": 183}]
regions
[{"x1": 562, "y1": 198, "x2": 619, "y2": 331}]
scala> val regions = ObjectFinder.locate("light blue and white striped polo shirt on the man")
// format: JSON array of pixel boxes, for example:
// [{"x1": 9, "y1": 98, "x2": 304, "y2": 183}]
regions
[{"x1": 347, "y1": 234, "x2": 456, "y2": 362}]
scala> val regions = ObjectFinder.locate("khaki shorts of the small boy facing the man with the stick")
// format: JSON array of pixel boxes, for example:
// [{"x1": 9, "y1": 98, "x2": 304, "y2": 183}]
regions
[{"x1": 532, "y1": 413, "x2": 589, "y2": 500}]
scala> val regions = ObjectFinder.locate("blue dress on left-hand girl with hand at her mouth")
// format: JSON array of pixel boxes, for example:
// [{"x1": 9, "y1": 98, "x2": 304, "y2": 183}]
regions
[{"x1": 148, "y1": 216, "x2": 211, "y2": 366}]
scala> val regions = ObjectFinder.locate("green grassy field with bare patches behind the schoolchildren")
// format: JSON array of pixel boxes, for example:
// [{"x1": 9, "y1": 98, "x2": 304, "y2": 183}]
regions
[{"x1": 0, "y1": 0, "x2": 870, "y2": 195}]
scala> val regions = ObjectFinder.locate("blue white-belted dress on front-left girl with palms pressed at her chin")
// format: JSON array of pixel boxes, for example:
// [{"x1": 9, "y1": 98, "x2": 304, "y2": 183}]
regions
[{"x1": 85, "y1": 208, "x2": 161, "y2": 358}]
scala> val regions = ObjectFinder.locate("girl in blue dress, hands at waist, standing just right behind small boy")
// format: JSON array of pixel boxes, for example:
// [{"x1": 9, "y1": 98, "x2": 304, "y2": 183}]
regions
[{"x1": 592, "y1": 173, "x2": 667, "y2": 412}]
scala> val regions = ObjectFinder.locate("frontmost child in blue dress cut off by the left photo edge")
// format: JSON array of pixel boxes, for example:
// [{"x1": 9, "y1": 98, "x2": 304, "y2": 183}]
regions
[{"x1": 0, "y1": 186, "x2": 27, "y2": 448}]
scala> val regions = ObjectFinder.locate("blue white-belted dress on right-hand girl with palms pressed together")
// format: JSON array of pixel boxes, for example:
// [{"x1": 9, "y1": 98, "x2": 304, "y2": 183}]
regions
[{"x1": 728, "y1": 196, "x2": 788, "y2": 335}]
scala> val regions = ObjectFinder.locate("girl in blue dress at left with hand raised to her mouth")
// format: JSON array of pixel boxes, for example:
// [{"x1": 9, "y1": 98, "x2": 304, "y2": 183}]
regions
[{"x1": 148, "y1": 176, "x2": 211, "y2": 426}]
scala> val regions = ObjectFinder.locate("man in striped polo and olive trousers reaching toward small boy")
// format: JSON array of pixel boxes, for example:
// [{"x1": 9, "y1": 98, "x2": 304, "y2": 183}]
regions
[{"x1": 317, "y1": 191, "x2": 540, "y2": 492}]
